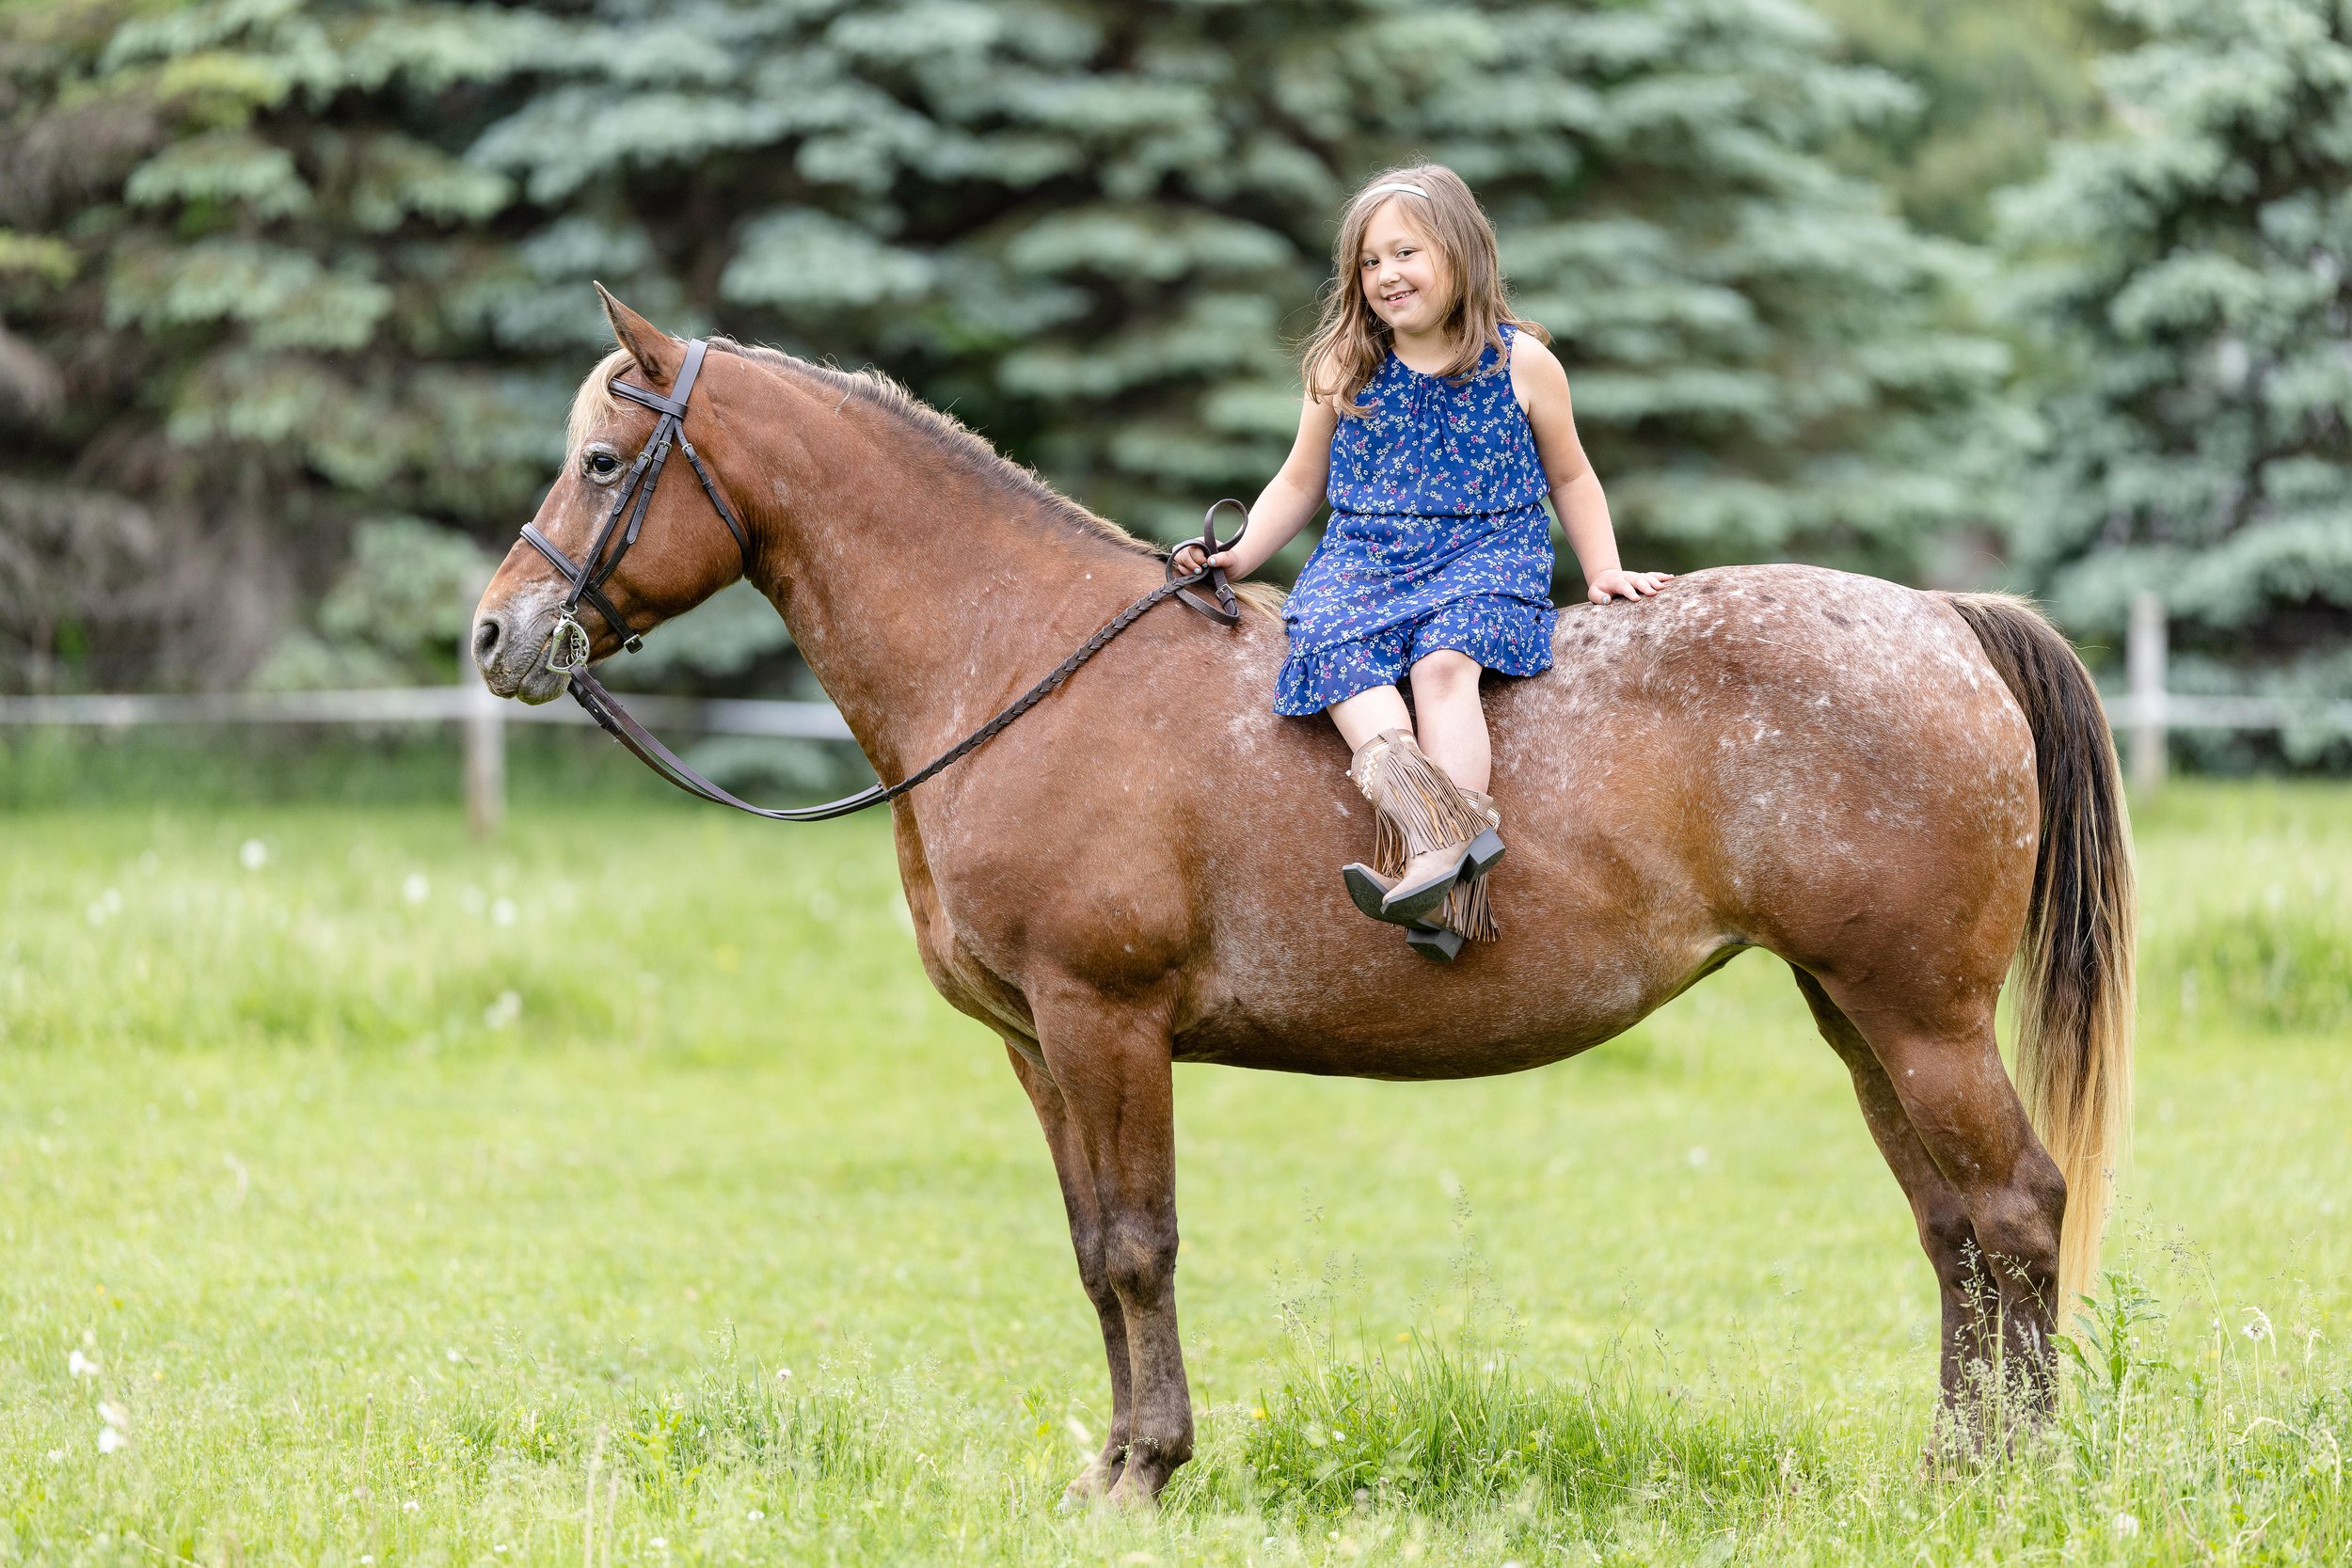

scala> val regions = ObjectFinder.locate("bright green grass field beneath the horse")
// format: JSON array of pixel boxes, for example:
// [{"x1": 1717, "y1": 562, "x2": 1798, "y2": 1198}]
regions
[{"x1": 0, "y1": 785, "x2": 2352, "y2": 1568}]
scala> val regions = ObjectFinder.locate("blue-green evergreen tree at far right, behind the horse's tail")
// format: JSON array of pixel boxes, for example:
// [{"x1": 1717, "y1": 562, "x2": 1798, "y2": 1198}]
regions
[{"x1": 2004, "y1": 0, "x2": 2352, "y2": 761}]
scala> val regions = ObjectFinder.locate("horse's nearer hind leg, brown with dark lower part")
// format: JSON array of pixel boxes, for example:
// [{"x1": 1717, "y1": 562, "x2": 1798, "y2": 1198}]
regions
[{"x1": 1823, "y1": 978, "x2": 2065, "y2": 1416}]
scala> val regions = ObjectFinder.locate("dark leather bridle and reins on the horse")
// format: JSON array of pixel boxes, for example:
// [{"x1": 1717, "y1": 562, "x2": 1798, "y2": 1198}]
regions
[{"x1": 522, "y1": 339, "x2": 1249, "y2": 823}]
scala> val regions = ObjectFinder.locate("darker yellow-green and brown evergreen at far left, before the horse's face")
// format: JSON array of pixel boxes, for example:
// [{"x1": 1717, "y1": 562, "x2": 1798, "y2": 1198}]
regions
[{"x1": 0, "y1": 0, "x2": 572, "y2": 687}]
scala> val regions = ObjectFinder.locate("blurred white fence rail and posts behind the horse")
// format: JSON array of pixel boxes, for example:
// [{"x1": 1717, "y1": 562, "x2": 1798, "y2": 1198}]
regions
[{"x1": 0, "y1": 594, "x2": 2352, "y2": 834}]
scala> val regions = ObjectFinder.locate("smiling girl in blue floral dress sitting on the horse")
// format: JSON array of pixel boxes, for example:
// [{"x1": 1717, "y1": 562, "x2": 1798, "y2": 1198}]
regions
[{"x1": 1179, "y1": 165, "x2": 1668, "y2": 959}]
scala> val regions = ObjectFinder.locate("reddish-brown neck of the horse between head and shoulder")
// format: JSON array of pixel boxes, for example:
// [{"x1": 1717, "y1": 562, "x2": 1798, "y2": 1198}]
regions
[{"x1": 739, "y1": 399, "x2": 1157, "y2": 778}]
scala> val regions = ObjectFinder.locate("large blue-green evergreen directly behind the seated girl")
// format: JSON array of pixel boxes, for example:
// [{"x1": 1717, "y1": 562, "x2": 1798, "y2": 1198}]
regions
[{"x1": 475, "y1": 0, "x2": 2004, "y2": 576}]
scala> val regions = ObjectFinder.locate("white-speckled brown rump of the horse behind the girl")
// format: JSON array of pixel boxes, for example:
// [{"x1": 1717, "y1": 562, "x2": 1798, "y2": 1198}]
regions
[{"x1": 1496, "y1": 566, "x2": 2037, "y2": 982}]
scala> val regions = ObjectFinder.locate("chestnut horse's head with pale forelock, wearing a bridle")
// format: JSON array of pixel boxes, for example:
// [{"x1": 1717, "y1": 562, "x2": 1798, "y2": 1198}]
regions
[{"x1": 473, "y1": 284, "x2": 751, "y2": 703}]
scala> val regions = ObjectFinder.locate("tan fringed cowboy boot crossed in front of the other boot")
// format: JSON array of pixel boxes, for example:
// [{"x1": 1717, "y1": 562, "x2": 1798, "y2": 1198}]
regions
[{"x1": 1341, "y1": 729, "x2": 1503, "y2": 927}]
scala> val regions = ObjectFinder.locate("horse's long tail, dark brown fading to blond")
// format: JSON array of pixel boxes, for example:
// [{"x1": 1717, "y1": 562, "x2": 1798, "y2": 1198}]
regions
[{"x1": 1946, "y1": 593, "x2": 2136, "y2": 1323}]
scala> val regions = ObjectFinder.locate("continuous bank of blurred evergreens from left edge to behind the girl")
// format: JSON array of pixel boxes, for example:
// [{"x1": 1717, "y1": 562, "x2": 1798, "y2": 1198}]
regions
[{"x1": 0, "y1": 0, "x2": 2004, "y2": 687}]
